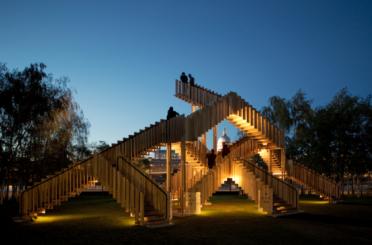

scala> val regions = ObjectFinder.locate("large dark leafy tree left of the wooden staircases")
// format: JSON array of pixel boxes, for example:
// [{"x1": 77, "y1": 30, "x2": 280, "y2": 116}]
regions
[{"x1": 0, "y1": 64, "x2": 89, "y2": 199}]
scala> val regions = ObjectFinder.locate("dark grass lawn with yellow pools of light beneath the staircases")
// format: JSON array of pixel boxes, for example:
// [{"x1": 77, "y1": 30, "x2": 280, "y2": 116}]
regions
[{"x1": 2, "y1": 195, "x2": 372, "y2": 245}]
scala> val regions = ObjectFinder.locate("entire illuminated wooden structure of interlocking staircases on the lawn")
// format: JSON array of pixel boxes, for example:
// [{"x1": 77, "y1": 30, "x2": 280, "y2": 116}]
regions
[{"x1": 20, "y1": 78, "x2": 340, "y2": 226}]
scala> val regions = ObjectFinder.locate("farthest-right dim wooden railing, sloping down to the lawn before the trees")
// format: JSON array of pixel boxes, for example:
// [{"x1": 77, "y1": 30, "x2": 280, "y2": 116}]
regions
[{"x1": 286, "y1": 160, "x2": 341, "y2": 199}]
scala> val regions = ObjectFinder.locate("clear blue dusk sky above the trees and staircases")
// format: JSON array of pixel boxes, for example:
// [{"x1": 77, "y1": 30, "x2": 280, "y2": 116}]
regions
[{"x1": 0, "y1": 0, "x2": 372, "y2": 143}]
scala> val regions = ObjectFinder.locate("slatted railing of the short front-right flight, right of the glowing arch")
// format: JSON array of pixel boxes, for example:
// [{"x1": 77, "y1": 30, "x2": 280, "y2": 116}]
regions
[{"x1": 243, "y1": 160, "x2": 298, "y2": 208}]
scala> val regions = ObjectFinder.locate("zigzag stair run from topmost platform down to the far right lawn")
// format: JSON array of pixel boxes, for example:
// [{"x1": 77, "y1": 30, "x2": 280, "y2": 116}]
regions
[{"x1": 176, "y1": 81, "x2": 341, "y2": 199}]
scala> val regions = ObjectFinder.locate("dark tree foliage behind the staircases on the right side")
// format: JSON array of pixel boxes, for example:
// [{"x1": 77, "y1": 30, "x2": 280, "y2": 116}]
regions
[{"x1": 263, "y1": 89, "x2": 372, "y2": 184}]
